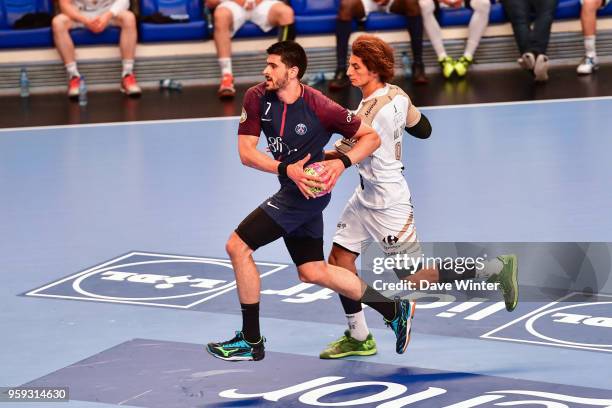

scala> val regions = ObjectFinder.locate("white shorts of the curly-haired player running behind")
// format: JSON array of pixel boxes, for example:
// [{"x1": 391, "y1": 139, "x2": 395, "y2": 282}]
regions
[{"x1": 333, "y1": 194, "x2": 421, "y2": 256}]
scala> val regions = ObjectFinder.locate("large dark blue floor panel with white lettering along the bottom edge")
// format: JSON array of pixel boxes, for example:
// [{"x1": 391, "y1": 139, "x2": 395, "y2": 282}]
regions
[{"x1": 27, "y1": 339, "x2": 612, "y2": 408}]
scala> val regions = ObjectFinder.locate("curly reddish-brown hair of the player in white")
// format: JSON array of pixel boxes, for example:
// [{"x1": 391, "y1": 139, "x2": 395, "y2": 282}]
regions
[{"x1": 353, "y1": 34, "x2": 395, "y2": 82}]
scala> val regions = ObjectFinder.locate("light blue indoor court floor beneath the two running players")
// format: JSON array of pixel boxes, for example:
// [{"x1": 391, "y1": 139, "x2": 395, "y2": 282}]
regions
[{"x1": 0, "y1": 98, "x2": 612, "y2": 408}]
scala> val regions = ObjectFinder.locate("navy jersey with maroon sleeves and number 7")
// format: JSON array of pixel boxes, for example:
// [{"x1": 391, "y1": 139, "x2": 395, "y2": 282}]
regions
[{"x1": 238, "y1": 82, "x2": 361, "y2": 195}]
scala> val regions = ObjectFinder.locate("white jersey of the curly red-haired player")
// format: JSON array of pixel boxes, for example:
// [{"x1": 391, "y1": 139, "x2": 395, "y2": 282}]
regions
[{"x1": 355, "y1": 84, "x2": 414, "y2": 209}]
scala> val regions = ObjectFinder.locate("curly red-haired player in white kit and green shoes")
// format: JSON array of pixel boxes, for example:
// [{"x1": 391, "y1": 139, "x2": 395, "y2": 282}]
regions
[{"x1": 320, "y1": 34, "x2": 518, "y2": 359}]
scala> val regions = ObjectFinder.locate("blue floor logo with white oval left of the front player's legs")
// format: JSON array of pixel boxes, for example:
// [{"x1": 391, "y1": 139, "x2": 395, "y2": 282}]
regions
[{"x1": 26, "y1": 252, "x2": 286, "y2": 309}]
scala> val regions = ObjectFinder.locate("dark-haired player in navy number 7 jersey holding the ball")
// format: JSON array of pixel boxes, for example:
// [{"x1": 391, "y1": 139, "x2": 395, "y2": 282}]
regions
[{"x1": 207, "y1": 41, "x2": 414, "y2": 361}]
